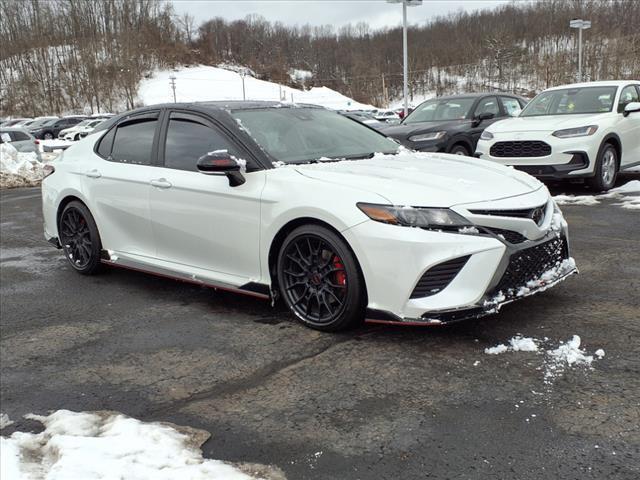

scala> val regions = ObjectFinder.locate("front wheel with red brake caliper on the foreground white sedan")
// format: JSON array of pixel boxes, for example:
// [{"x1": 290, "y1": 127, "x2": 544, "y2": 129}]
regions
[{"x1": 277, "y1": 225, "x2": 366, "y2": 332}]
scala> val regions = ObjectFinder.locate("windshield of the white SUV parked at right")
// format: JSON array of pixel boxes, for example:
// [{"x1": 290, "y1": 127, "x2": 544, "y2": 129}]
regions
[{"x1": 520, "y1": 87, "x2": 617, "y2": 117}]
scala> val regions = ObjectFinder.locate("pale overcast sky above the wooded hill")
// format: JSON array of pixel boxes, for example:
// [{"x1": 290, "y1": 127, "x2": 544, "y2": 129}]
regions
[{"x1": 172, "y1": 0, "x2": 508, "y2": 28}]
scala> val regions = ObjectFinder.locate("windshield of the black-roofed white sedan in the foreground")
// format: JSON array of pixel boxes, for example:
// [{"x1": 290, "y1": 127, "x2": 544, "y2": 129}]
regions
[{"x1": 232, "y1": 108, "x2": 399, "y2": 163}]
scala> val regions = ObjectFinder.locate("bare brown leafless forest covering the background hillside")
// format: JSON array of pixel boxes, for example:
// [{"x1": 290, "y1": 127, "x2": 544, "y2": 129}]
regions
[{"x1": 0, "y1": 0, "x2": 640, "y2": 115}]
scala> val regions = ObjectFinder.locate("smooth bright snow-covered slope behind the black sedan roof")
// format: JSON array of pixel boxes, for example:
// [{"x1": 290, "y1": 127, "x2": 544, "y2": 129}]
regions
[{"x1": 138, "y1": 65, "x2": 375, "y2": 110}]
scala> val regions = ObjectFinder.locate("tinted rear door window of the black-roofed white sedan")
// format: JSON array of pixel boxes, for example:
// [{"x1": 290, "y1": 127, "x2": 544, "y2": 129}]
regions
[{"x1": 110, "y1": 117, "x2": 158, "y2": 165}]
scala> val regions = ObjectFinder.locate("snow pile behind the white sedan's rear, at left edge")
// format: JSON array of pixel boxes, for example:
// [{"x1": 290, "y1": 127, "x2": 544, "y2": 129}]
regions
[{"x1": 0, "y1": 143, "x2": 43, "y2": 188}]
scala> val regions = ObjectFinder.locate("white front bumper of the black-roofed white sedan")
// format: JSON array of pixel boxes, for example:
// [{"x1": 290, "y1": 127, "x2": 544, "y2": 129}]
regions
[{"x1": 343, "y1": 199, "x2": 577, "y2": 325}]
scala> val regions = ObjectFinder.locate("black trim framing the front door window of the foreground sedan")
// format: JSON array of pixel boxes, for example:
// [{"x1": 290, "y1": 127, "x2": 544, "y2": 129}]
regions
[{"x1": 158, "y1": 108, "x2": 265, "y2": 173}]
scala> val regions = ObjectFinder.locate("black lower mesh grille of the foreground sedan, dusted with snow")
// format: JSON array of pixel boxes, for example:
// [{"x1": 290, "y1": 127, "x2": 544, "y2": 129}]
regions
[{"x1": 494, "y1": 238, "x2": 569, "y2": 298}]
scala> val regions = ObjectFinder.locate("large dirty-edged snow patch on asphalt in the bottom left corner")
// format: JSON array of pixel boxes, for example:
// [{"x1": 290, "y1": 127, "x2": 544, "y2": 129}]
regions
[{"x1": 0, "y1": 410, "x2": 284, "y2": 480}]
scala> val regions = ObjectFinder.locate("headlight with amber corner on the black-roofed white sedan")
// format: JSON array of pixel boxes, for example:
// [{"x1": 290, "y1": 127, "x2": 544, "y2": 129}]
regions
[{"x1": 357, "y1": 203, "x2": 471, "y2": 229}]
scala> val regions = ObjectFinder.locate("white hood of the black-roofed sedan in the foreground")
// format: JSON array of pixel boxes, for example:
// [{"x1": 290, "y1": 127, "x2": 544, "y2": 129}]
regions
[{"x1": 290, "y1": 151, "x2": 543, "y2": 207}]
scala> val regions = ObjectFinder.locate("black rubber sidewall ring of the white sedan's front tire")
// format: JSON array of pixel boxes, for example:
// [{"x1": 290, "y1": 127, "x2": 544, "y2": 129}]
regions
[{"x1": 276, "y1": 225, "x2": 366, "y2": 332}]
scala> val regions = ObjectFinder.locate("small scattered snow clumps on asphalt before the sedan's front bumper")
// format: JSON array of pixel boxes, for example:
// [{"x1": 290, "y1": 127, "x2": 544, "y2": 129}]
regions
[{"x1": 484, "y1": 335, "x2": 605, "y2": 385}]
